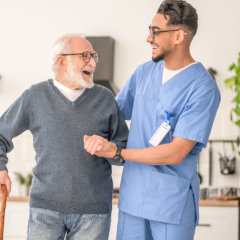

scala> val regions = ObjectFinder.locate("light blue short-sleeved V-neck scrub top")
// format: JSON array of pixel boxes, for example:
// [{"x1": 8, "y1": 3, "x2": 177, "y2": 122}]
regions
[{"x1": 116, "y1": 61, "x2": 220, "y2": 224}]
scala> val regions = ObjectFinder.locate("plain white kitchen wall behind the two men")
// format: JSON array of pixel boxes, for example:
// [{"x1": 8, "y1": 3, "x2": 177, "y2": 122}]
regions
[{"x1": 0, "y1": 0, "x2": 240, "y2": 194}]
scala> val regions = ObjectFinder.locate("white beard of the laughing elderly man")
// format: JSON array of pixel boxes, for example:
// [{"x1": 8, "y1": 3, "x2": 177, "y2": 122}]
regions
[{"x1": 64, "y1": 61, "x2": 94, "y2": 88}]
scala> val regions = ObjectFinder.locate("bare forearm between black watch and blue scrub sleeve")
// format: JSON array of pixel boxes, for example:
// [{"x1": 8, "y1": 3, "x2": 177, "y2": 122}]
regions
[{"x1": 121, "y1": 138, "x2": 196, "y2": 165}]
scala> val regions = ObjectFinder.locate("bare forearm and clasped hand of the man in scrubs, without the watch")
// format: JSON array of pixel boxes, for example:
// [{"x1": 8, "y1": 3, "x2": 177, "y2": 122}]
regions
[{"x1": 84, "y1": 135, "x2": 196, "y2": 165}]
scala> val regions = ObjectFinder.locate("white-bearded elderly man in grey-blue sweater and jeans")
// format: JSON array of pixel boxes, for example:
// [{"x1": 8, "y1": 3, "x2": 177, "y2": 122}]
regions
[{"x1": 0, "y1": 35, "x2": 128, "y2": 240}]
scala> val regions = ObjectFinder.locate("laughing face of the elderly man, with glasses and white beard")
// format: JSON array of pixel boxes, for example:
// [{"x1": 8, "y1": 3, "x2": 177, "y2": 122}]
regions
[{"x1": 65, "y1": 37, "x2": 96, "y2": 88}]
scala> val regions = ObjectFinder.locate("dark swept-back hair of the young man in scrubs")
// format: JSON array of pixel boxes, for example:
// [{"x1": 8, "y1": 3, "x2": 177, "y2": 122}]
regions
[{"x1": 157, "y1": 0, "x2": 198, "y2": 36}]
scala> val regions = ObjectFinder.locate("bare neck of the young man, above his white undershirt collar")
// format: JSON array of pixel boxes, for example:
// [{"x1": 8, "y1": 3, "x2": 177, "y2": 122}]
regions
[{"x1": 164, "y1": 52, "x2": 196, "y2": 70}]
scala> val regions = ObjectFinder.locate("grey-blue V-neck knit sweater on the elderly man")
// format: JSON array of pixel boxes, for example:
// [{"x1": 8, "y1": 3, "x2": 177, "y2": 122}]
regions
[{"x1": 0, "y1": 79, "x2": 128, "y2": 214}]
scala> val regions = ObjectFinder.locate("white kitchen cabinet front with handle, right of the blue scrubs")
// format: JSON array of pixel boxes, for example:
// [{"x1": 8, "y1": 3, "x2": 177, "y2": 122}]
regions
[{"x1": 194, "y1": 202, "x2": 240, "y2": 240}]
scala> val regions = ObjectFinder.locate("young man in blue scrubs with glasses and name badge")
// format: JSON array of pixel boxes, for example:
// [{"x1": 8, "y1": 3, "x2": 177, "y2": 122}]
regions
[{"x1": 84, "y1": 0, "x2": 220, "y2": 240}]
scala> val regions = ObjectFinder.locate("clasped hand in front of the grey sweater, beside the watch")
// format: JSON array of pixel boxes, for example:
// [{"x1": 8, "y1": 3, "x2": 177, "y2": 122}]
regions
[{"x1": 83, "y1": 135, "x2": 117, "y2": 158}]
